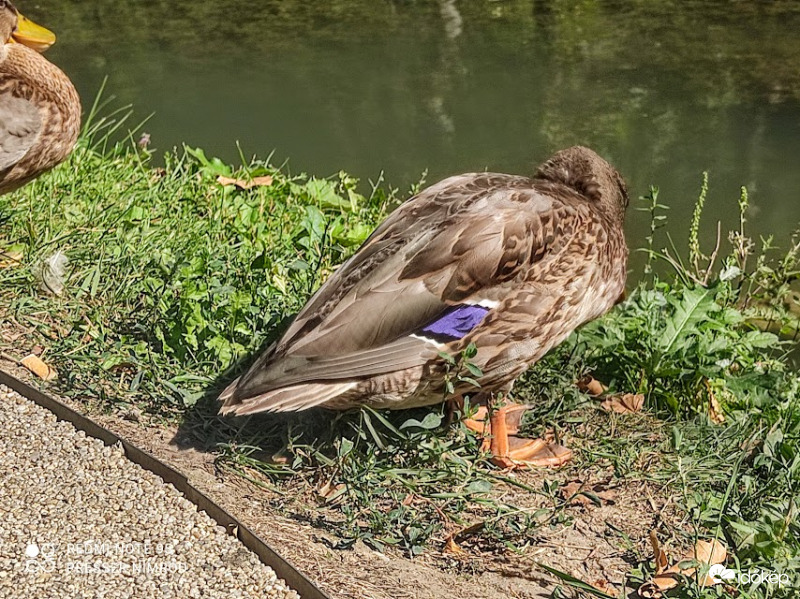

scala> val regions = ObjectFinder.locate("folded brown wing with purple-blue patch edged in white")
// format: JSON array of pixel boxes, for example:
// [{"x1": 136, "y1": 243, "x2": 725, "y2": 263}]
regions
[{"x1": 220, "y1": 173, "x2": 585, "y2": 409}]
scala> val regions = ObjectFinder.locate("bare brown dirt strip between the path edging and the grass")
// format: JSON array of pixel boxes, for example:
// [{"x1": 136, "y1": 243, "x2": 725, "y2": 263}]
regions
[{"x1": 0, "y1": 359, "x2": 680, "y2": 599}]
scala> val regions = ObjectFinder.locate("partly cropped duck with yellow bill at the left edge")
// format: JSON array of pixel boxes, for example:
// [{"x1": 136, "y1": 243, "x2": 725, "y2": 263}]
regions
[{"x1": 0, "y1": 0, "x2": 81, "y2": 194}]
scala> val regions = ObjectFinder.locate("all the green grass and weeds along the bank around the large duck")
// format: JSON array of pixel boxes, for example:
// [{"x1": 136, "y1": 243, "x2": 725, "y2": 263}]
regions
[{"x1": 0, "y1": 119, "x2": 800, "y2": 598}]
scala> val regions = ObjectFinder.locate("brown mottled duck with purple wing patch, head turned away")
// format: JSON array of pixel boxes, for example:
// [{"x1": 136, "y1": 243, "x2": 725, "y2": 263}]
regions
[{"x1": 219, "y1": 146, "x2": 629, "y2": 468}]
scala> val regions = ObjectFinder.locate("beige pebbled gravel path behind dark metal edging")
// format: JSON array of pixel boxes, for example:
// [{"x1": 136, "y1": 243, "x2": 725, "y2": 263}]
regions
[{"x1": 0, "y1": 386, "x2": 298, "y2": 599}]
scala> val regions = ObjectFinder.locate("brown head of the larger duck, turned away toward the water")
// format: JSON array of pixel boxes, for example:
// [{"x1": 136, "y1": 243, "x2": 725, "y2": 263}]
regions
[{"x1": 534, "y1": 146, "x2": 629, "y2": 223}]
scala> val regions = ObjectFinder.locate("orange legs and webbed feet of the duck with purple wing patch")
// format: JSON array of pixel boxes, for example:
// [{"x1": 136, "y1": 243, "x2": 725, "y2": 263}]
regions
[{"x1": 464, "y1": 403, "x2": 572, "y2": 468}]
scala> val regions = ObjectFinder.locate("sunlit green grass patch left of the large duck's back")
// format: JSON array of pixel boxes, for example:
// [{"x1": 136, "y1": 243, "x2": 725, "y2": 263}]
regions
[{"x1": 0, "y1": 109, "x2": 393, "y2": 410}]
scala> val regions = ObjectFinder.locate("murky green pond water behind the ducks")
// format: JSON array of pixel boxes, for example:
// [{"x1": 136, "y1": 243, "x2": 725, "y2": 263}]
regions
[{"x1": 28, "y1": 0, "x2": 800, "y2": 268}]
